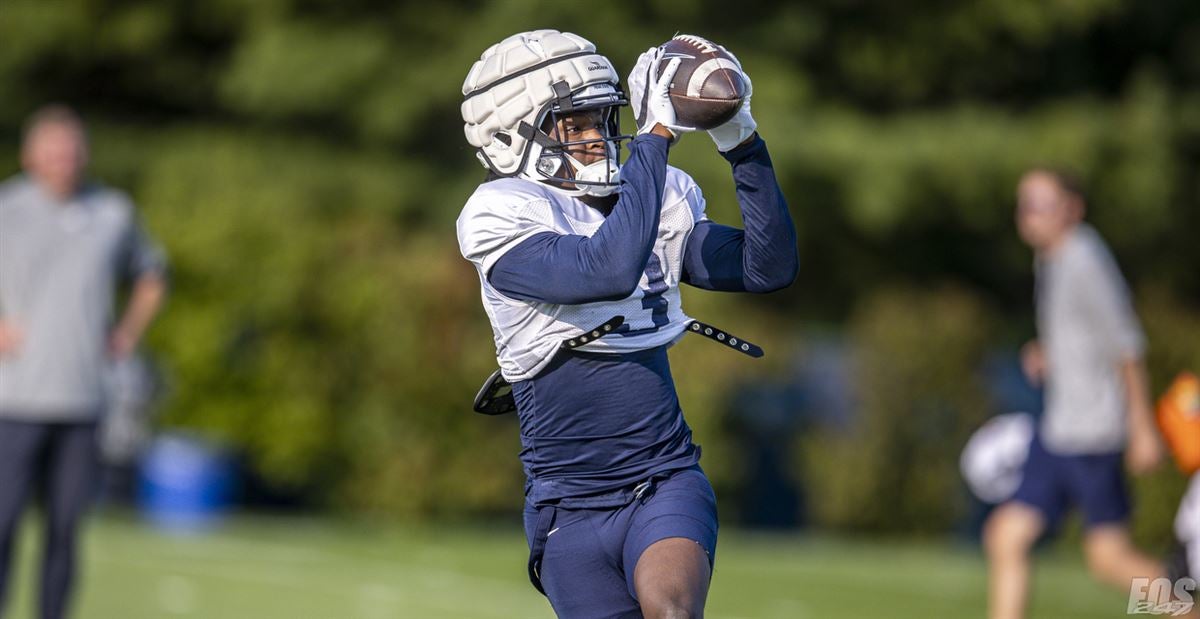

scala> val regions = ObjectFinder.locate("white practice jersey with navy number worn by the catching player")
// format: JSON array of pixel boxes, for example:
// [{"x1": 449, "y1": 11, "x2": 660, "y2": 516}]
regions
[{"x1": 457, "y1": 166, "x2": 704, "y2": 381}]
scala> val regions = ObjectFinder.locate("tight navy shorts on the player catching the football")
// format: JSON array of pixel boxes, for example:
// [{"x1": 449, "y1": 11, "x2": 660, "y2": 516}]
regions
[{"x1": 524, "y1": 467, "x2": 716, "y2": 619}]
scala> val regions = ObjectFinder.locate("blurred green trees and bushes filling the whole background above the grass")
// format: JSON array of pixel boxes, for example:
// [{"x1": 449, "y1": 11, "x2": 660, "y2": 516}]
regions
[{"x1": 0, "y1": 0, "x2": 1200, "y2": 534}]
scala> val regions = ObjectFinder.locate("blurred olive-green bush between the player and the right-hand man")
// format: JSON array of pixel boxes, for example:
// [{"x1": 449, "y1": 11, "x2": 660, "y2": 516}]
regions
[{"x1": 797, "y1": 290, "x2": 995, "y2": 533}]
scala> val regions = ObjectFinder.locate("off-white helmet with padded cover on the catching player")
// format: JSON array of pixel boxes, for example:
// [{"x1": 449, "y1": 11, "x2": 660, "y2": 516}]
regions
[{"x1": 462, "y1": 30, "x2": 630, "y2": 196}]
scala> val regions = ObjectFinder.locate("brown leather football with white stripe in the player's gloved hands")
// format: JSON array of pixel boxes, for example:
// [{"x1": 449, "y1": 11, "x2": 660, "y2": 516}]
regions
[{"x1": 659, "y1": 35, "x2": 748, "y2": 130}]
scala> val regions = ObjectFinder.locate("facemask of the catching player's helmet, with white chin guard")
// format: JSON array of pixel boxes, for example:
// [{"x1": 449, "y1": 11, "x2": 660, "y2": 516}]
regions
[{"x1": 521, "y1": 83, "x2": 631, "y2": 197}]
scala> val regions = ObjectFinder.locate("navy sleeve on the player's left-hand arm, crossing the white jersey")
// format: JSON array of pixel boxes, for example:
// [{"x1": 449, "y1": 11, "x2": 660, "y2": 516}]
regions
[{"x1": 487, "y1": 134, "x2": 667, "y2": 305}]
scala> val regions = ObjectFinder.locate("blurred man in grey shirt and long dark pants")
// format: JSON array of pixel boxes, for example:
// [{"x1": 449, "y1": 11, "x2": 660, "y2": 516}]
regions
[{"x1": 0, "y1": 106, "x2": 164, "y2": 619}]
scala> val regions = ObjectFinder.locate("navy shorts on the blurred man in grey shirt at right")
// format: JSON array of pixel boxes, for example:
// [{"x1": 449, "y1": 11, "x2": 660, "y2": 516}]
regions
[{"x1": 1013, "y1": 437, "x2": 1129, "y2": 529}]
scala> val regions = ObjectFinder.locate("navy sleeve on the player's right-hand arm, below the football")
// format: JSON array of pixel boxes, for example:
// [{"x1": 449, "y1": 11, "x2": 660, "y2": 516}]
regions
[{"x1": 683, "y1": 136, "x2": 799, "y2": 293}]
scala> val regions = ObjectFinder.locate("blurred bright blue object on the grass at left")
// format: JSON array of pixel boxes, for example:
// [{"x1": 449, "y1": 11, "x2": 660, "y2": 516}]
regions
[{"x1": 138, "y1": 434, "x2": 238, "y2": 533}]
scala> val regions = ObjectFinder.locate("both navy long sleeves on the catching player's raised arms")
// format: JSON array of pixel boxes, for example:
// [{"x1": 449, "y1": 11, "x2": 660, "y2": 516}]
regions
[{"x1": 488, "y1": 136, "x2": 798, "y2": 305}]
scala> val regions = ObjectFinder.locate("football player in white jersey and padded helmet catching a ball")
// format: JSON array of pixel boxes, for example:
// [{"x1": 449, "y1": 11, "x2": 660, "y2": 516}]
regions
[{"x1": 457, "y1": 30, "x2": 797, "y2": 618}]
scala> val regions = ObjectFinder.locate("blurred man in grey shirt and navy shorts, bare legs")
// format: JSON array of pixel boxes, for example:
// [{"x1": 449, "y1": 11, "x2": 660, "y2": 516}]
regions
[{"x1": 984, "y1": 168, "x2": 1165, "y2": 619}]
